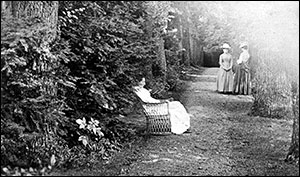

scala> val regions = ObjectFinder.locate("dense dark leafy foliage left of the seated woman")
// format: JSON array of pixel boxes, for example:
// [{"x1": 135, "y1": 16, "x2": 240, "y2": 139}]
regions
[{"x1": 1, "y1": 1, "x2": 171, "y2": 170}]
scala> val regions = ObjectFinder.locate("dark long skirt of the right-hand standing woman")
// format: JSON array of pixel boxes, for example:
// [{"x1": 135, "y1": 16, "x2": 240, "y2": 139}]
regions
[{"x1": 233, "y1": 65, "x2": 251, "y2": 95}]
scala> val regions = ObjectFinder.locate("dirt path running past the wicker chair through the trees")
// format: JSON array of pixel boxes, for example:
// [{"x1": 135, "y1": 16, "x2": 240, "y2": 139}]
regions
[{"x1": 51, "y1": 66, "x2": 299, "y2": 176}]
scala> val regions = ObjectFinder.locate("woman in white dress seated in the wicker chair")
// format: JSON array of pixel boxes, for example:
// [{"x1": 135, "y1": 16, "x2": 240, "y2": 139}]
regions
[{"x1": 134, "y1": 78, "x2": 191, "y2": 134}]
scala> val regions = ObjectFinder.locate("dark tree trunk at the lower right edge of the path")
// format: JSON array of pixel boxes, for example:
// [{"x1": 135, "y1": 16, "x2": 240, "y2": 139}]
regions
[{"x1": 286, "y1": 83, "x2": 299, "y2": 161}]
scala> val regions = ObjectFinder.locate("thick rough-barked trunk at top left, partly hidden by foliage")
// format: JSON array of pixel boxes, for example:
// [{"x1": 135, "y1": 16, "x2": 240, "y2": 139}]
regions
[{"x1": 1, "y1": 1, "x2": 58, "y2": 95}]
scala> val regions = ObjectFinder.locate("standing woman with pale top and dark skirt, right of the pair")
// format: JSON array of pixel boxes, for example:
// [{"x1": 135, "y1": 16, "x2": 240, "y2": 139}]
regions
[{"x1": 233, "y1": 43, "x2": 251, "y2": 95}]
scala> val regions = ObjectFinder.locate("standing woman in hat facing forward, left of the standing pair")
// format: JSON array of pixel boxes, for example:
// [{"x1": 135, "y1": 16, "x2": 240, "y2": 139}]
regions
[{"x1": 217, "y1": 43, "x2": 233, "y2": 93}]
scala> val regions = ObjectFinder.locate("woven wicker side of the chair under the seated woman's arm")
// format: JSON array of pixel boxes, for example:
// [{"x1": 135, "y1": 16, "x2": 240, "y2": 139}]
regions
[{"x1": 142, "y1": 102, "x2": 171, "y2": 134}]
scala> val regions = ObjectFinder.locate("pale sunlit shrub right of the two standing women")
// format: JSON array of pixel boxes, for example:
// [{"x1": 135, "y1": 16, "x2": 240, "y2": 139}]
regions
[{"x1": 251, "y1": 54, "x2": 292, "y2": 119}]
